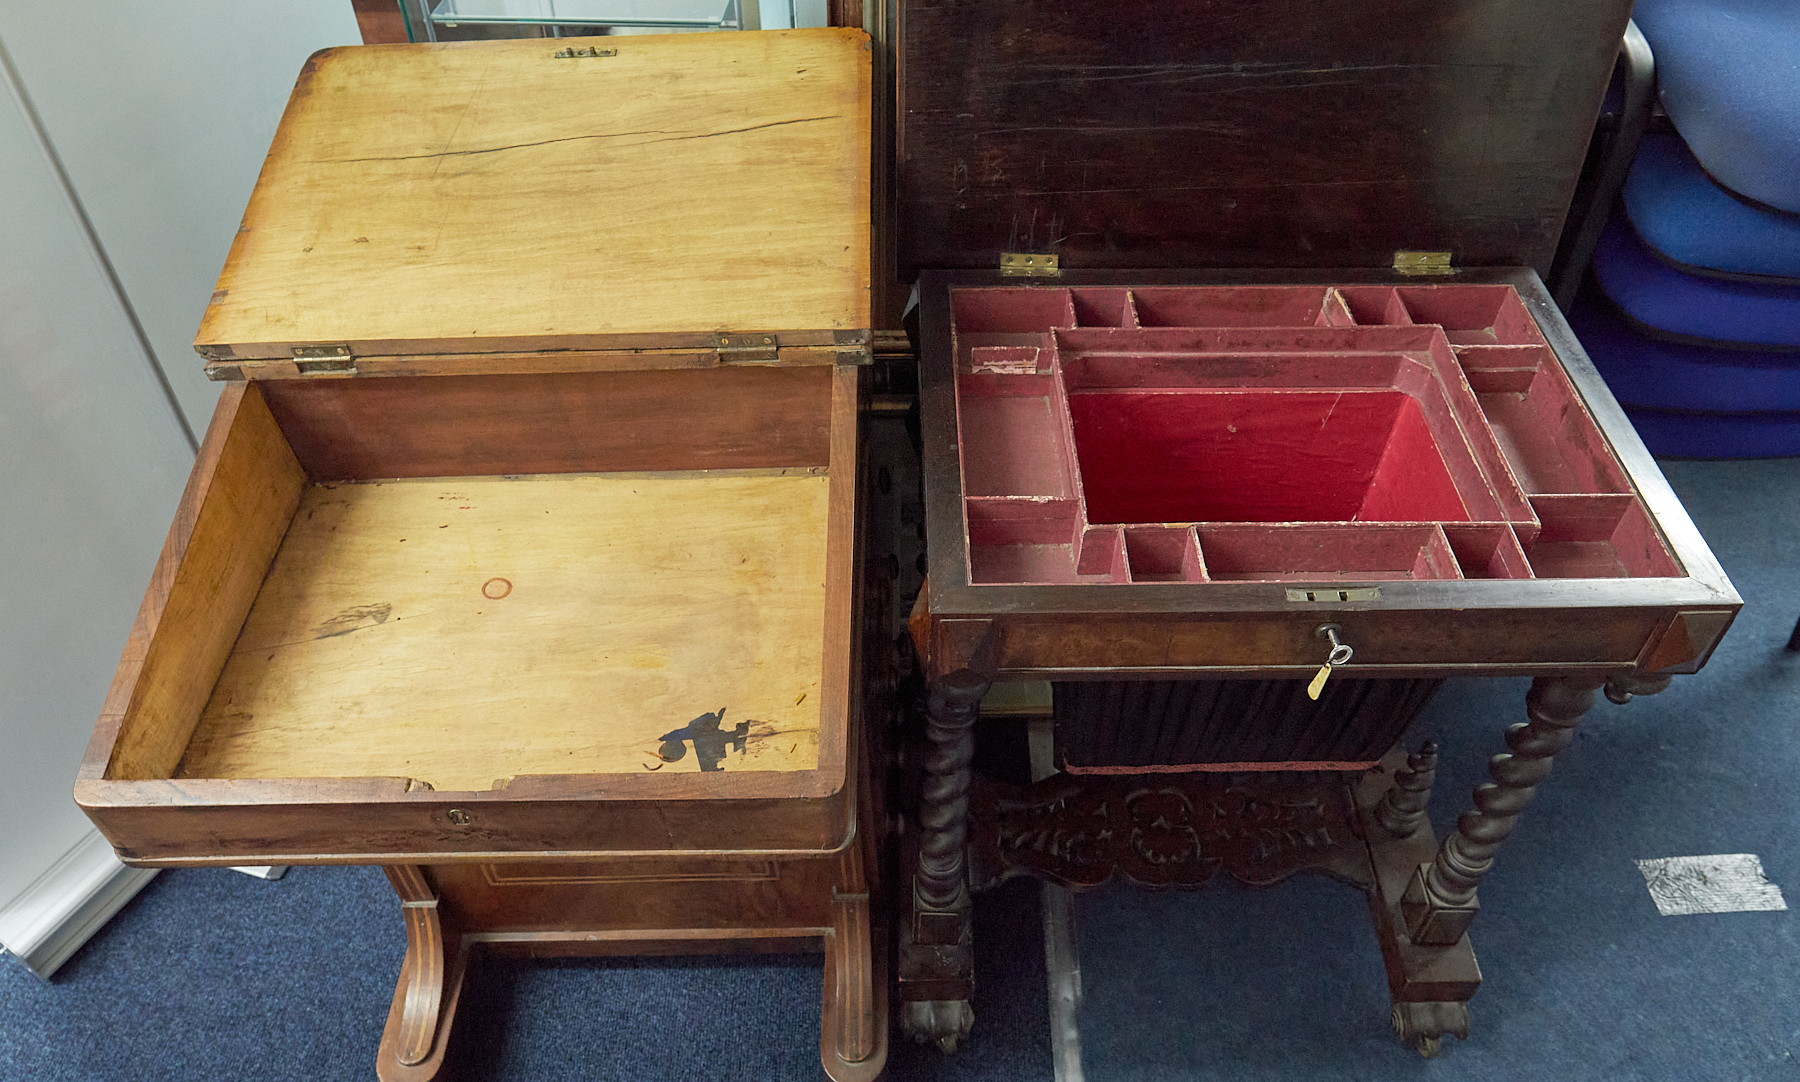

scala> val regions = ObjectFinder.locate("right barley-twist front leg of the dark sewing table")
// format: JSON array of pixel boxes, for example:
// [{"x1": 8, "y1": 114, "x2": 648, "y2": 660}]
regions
[{"x1": 1400, "y1": 677, "x2": 1604, "y2": 947}]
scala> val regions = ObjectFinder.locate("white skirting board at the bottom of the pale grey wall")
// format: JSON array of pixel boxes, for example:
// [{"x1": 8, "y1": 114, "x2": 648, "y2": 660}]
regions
[{"x1": 0, "y1": 832, "x2": 157, "y2": 979}]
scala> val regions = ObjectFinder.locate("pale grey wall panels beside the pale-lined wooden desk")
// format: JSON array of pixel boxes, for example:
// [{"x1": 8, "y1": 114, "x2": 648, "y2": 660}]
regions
[{"x1": 0, "y1": 0, "x2": 360, "y2": 907}]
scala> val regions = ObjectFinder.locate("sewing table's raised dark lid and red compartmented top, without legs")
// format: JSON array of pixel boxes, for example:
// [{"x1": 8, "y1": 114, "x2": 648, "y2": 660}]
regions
[{"x1": 898, "y1": 0, "x2": 1741, "y2": 681}]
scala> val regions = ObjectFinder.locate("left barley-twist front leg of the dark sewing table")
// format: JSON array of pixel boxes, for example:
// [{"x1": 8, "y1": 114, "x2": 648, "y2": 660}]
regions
[{"x1": 900, "y1": 670, "x2": 988, "y2": 1053}]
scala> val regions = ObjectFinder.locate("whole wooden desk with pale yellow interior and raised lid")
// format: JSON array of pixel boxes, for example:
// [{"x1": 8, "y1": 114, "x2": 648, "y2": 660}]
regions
[{"x1": 76, "y1": 31, "x2": 887, "y2": 1082}]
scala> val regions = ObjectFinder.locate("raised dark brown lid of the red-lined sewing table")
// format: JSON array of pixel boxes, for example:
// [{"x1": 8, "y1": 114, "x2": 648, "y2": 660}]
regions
[{"x1": 898, "y1": 0, "x2": 1631, "y2": 277}]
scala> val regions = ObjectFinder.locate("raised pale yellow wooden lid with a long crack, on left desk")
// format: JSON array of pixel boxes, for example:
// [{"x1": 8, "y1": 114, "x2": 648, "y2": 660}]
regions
[{"x1": 194, "y1": 29, "x2": 869, "y2": 367}]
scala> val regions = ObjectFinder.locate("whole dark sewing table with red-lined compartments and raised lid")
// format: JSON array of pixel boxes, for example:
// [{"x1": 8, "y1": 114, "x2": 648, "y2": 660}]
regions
[{"x1": 896, "y1": 0, "x2": 1741, "y2": 1053}]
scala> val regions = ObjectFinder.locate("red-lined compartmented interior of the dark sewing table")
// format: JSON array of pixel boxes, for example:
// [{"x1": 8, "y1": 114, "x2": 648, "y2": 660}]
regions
[{"x1": 952, "y1": 284, "x2": 1679, "y2": 583}]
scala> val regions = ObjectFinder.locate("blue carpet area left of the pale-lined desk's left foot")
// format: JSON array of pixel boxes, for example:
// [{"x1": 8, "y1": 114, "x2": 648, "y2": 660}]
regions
[{"x1": 0, "y1": 868, "x2": 405, "y2": 1082}]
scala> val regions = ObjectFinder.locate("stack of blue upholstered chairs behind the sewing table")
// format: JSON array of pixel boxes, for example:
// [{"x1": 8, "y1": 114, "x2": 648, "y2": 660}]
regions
[{"x1": 1570, "y1": 0, "x2": 1800, "y2": 457}]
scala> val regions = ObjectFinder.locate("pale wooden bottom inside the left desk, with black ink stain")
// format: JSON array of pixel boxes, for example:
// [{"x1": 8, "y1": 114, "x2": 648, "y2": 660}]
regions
[{"x1": 178, "y1": 470, "x2": 830, "y2": 790}]
